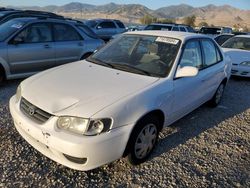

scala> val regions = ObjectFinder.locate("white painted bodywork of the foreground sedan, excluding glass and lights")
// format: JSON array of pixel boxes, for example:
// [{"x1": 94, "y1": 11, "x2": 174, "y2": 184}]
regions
[{"x1": 10, "y1": 31, "x2": 230, "y2": 170}]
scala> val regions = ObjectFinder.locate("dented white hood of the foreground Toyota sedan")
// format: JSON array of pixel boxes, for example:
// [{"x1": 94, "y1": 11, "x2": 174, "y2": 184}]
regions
[{"x1": 21, "y1": 61, "x2": 159, "y2": 118}]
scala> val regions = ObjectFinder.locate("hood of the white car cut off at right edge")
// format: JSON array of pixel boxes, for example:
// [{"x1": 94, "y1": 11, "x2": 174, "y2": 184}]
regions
[{"x1": 222, "y1": 48, "x2": 250, "y2": 65}]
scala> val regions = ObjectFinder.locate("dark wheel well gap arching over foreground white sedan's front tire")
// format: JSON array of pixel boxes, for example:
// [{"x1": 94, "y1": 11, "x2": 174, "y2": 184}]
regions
[{"x1": 123, "y1": 110, "x2": 165, "y2": 157}]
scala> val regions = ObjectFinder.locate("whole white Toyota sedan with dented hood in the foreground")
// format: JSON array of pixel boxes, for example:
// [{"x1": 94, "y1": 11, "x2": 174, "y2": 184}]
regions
[{"x1": 10, "y1": 31, "x2": 230, "y2": 170}]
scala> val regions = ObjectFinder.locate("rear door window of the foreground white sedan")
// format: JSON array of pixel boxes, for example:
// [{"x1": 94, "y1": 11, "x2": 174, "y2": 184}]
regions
[{"x1": 202, "y1": 40, "x2": 217, "y2": 66}]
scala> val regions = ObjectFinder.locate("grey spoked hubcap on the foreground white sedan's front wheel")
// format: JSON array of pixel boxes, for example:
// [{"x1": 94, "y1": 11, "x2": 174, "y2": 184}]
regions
[{"x1": 135, "y1": 124, "x2": 157, "y2": 159}]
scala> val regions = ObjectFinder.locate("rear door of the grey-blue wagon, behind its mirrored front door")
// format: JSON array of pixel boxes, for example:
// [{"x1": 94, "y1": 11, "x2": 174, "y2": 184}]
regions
[{"x1": 53, "y1": 23, "x2": 84, "y2": 65}]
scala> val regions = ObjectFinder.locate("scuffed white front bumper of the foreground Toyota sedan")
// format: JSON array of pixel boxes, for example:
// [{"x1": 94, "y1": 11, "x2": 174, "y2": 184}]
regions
[{"x1": 10, "y1": 96, "x2": 133, "y2": 171}]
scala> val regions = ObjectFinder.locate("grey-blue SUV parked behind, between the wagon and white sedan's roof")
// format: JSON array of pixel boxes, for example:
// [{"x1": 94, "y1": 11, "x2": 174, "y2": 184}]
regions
[{"x1": 84, "y1": 19, "x2": 126, "y2": 41}]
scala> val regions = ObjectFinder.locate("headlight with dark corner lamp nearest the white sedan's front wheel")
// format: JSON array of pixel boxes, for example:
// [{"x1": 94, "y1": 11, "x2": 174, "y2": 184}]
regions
[{"x1": 57, "y1": 116, "x2": 112, "y2": 136}]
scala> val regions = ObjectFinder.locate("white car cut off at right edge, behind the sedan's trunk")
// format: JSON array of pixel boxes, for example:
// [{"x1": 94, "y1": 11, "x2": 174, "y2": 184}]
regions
[{"x1": 222, "y1": 35, "x2": 250, "y2": 77}]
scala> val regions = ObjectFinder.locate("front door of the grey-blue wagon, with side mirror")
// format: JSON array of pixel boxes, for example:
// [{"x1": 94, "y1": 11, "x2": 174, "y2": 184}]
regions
[{"x1": 8, "y1": 23, "x2": 55, "y2": 74}]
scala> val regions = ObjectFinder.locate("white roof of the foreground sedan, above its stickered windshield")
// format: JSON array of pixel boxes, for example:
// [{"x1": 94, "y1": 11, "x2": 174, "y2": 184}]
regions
[{"x1": 125, "y1": 30, "x2": 211, "y2": 40}]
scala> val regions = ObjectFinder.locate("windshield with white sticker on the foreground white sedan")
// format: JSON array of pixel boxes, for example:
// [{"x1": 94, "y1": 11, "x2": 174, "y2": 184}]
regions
[{"x1": 88, "y1": 35, "x2": 181, "y2": 77}]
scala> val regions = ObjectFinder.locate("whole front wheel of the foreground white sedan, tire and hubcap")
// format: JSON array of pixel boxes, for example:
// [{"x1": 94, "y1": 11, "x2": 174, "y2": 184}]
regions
[{"x1": 127, "y1": 116, "x2": 160, "y2": 165}]
